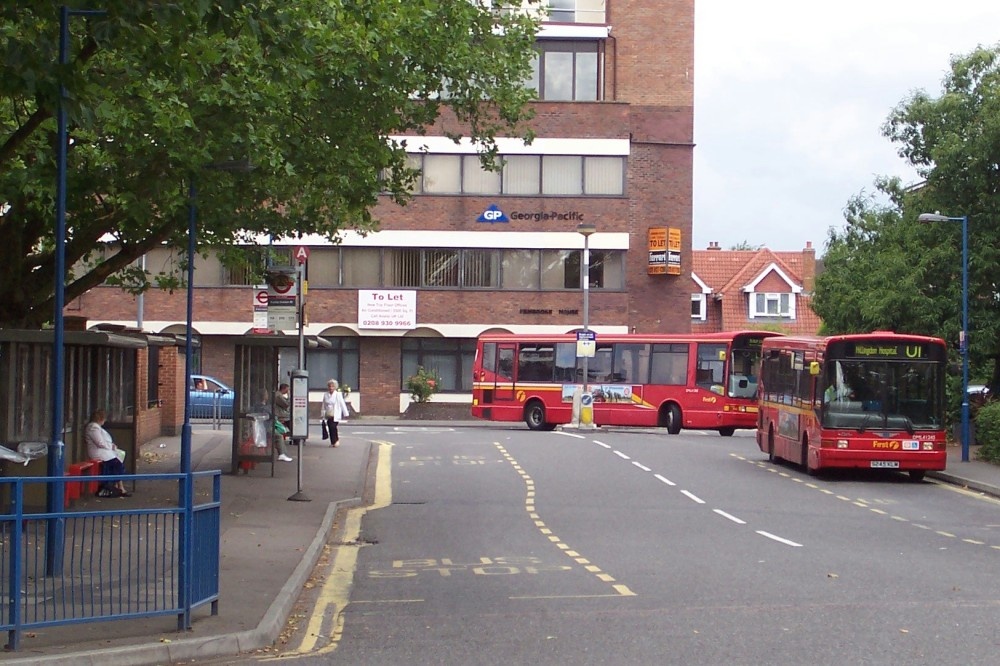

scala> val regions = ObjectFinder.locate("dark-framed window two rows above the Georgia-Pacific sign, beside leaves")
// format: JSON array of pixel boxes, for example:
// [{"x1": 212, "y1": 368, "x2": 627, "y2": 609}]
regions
[{"x1": 525, "y1": 41, "x2": 598, "y2": 101}]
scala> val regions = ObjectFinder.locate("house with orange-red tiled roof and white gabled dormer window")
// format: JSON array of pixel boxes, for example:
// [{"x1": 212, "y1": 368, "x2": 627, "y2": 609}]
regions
[{"x1": 691, "y1": 242, "x2": 822, "y2": 335}]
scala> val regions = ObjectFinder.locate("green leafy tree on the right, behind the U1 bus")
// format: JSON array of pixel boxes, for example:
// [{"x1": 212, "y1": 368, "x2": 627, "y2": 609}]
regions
[{"x1": 813, "y1": 47, "x2": 1000, "y2": 387}]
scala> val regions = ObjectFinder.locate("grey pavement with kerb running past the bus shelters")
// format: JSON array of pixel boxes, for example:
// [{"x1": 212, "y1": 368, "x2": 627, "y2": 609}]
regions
[{"x1": 7, "y1": 419, "x2": 1000, "y2": 666}]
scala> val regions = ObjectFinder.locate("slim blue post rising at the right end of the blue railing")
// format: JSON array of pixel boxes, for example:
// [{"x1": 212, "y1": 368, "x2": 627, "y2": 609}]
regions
[{"x1": 177, "y1": 175, "x2": 198, "y2": 631}]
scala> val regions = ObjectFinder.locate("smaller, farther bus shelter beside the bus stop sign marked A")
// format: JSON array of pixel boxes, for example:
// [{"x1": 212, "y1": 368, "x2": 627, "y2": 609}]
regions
[{"x1": 230, "y1": 334, "x2": 330, "y2": 476}]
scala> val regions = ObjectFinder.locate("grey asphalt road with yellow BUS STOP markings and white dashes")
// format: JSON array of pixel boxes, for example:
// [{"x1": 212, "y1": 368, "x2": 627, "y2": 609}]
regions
[{"x1": 270, "y1": 428, "x2": 1000, "y2": 665}]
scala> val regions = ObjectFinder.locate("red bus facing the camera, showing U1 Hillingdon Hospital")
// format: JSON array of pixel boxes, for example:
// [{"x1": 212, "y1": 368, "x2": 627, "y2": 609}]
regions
[{"x1": 757, "y1": 331, "x2": 948, "y2": 481}]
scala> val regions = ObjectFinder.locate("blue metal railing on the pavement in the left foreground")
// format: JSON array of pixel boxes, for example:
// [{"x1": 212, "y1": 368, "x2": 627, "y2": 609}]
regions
[{"x1": 0, "y1": 470, "x2": 222, "y2": 650}]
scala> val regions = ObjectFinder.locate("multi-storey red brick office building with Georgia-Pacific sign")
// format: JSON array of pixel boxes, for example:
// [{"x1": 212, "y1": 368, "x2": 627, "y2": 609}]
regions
[{"x1": 67, "y1": 0, "x2": 694, "y2": 414}]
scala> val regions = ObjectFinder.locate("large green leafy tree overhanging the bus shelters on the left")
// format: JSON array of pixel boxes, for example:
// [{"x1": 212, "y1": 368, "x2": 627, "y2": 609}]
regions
[{"x1": 0, "y1": 0, "x2": 538, "y2": 327}]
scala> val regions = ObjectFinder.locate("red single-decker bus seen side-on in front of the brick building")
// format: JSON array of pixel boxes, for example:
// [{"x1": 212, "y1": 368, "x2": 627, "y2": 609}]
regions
[{"x1": 472, "y1": 331, "x2": 778, "y2": 436}]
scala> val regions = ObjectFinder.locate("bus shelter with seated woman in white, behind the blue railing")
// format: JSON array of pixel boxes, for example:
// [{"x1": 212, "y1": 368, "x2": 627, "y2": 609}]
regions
[{"x1": 0, "y1": 329, "x2": 148, "y2": 511}]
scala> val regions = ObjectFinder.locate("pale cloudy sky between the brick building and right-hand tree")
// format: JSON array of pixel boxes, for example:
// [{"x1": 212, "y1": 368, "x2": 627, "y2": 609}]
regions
[{"x1": 692, "y1": 0, "x2": 1000, "y2": 254}]
